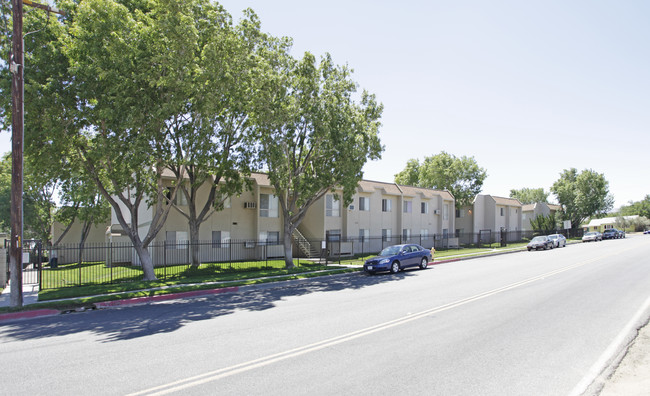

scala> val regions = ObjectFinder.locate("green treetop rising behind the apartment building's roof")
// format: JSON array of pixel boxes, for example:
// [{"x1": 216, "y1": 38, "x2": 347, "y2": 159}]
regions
[{"x1": 395, "y1": 151, "x2": 487, "y2": 207}]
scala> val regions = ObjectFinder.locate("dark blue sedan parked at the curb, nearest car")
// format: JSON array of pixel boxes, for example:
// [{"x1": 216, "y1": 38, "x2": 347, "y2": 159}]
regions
[{"x1": 363, "y1": 244, "x2": 431, "y2": 274}]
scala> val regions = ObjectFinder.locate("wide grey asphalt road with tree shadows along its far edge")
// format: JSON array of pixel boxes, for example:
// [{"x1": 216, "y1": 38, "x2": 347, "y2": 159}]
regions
[{"x1": 0, "y1": 235, "x2": 650, "y2": 395}]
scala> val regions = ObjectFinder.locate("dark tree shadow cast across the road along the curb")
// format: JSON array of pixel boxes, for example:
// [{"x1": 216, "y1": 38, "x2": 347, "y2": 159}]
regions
[{"x1": 0, "y1": 268, "x2": 431, "y2": 342}]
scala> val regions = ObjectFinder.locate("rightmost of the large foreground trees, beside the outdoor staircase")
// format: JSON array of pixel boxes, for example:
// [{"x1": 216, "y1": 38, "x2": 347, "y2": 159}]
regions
[{"x1": 258, "y1": 51, "x2": 383, "y2": 268}]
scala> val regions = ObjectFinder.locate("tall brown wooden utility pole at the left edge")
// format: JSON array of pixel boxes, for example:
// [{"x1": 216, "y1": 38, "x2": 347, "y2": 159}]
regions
[{"x1": 9, "y1": 0, "x2": 63, "y2": 307}]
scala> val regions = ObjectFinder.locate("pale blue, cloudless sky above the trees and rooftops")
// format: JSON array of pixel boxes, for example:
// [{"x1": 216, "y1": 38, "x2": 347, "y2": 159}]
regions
[{"x1": 0, "y1": 0, "x2": 650, "y2": 207}]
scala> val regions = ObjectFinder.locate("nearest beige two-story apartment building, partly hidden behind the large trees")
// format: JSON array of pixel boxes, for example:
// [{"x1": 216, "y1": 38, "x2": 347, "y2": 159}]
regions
[{"x1": 54, "y1": 173, "x2": 455, "y2": 263}]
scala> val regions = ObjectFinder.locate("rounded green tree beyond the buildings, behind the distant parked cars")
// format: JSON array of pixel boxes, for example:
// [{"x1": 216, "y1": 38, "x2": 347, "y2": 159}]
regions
[{"x1": 551, "y1": 168, "x2": 614, "y2": 228}]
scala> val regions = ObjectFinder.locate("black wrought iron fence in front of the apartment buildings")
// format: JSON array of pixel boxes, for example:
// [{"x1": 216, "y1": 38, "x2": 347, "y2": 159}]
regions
[{"x1": 39, "y1": 230, "x2": 582, "y2": 289}]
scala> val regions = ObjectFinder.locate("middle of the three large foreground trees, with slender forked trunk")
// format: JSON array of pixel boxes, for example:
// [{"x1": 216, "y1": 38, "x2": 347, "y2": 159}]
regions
[{"x1": 167, "y1": 9, "x2": 270, "y2": 266}]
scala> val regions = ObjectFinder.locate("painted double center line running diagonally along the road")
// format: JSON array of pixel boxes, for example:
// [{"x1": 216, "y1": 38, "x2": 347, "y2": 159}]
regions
[{"x1": 127, "y1": 251, "x2": 621, "y2": 396}]
